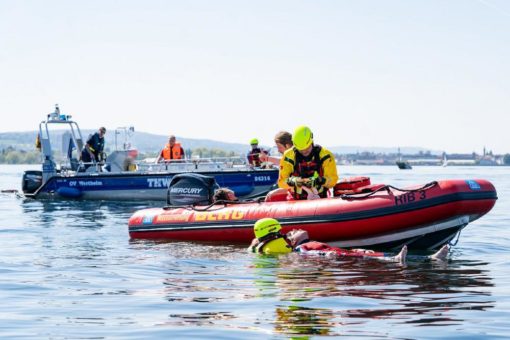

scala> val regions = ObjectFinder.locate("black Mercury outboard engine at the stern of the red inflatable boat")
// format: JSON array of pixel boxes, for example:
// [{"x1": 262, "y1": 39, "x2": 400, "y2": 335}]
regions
[{"x1": 166, "y1": 173, "x2": 219, "y2": 206}]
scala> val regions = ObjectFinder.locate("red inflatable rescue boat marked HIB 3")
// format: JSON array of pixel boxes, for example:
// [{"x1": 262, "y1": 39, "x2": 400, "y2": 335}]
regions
[{"x1": 129, "y1": 177, "x2": 497, "y2": 250}]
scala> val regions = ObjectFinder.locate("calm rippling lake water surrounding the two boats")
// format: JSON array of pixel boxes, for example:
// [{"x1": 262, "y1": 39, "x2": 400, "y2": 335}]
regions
[{"x1": 0, "y1": 165, "x2": 510, "y2": 339}]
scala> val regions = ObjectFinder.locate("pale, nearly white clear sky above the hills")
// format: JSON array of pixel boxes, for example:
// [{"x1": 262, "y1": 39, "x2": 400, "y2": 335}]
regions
[{"x1": 0, "y1": 0, "x2": 510, "y2": 153}]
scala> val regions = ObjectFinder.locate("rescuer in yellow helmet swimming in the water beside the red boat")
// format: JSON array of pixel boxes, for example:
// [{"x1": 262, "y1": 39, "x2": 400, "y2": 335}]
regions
[{"x1": 249, "y1": 217, "x2": 292, "y2": 254}]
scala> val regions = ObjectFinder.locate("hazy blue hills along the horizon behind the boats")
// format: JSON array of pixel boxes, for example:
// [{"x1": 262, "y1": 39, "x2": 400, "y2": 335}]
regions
[{"x1": 0, "y1": 130, "x2": 442, "y2": 155}]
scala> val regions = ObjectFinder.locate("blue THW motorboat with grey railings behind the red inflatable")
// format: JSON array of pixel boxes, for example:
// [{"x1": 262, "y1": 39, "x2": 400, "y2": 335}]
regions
[{"x1": 22, "y1": 106, "x2": 278, "y2": 201}]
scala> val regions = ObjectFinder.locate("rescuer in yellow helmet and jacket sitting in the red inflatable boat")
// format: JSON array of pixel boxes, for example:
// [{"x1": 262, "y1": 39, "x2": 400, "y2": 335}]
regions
[{"x1": 278, "y1": 126, "x2": 338, "y2": 200}]
